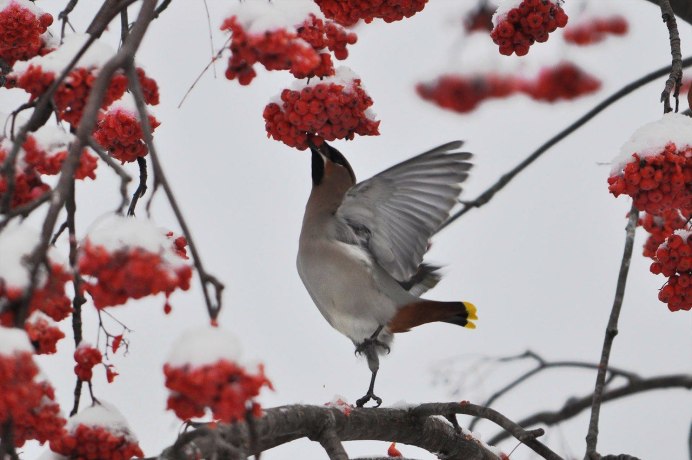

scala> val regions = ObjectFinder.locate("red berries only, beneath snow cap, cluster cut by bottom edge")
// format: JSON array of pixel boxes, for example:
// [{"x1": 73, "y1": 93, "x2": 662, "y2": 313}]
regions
[{"x1": 50, "y1": 423, "x2": 144, "y2": 460}]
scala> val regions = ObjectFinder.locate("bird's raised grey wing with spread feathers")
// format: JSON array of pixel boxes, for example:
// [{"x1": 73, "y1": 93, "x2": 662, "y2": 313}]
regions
[{"x1": 336, "y1": 141, "x2": 472, "y2": 282}]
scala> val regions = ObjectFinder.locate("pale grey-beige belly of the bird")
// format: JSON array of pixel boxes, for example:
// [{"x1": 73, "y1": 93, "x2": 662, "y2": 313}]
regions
[{"x1": 297, "y1": 242, "x2": 397, "y2": 343}]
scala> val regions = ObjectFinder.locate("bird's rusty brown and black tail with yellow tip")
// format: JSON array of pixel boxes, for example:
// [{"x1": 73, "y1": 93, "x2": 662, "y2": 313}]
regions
[{"x1": 387, "y1": 299, "x2": 478, "y2": 332}]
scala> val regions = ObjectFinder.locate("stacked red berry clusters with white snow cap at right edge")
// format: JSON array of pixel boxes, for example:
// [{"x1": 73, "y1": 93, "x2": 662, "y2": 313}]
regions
[{"x1": 608, "y1": 113, "x2": 692, "y2": 311}]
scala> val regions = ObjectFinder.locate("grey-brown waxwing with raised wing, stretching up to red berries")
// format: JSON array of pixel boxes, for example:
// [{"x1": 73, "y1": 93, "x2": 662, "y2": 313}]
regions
[{"x1": 296, "y1": 140, "x2": 478, "y2": 407}]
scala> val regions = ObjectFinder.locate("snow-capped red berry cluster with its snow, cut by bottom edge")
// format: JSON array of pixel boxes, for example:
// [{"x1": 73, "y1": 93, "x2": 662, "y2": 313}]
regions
[{"x1": 50, "y1": 403, "x2": 144, "y2": 460}]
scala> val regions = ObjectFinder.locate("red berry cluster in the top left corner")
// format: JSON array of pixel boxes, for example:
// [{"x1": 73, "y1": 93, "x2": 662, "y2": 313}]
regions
[{"x1": 0, "y1": 0, "x2": 53, "y2": 67}]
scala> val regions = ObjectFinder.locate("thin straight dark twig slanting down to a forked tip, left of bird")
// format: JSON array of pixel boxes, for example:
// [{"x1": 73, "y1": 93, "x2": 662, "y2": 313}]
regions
[{"x1": 126, "y1": 65, "x2": 224, "y2": 320}]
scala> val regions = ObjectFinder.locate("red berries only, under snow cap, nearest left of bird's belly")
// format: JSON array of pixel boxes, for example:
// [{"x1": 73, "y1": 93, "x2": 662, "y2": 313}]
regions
[{"x1": 79, "y1": 235, "x2": 192, "y2": 308}]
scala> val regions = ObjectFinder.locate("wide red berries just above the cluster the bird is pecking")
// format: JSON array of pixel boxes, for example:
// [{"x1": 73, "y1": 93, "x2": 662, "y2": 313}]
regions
[{"x1": 221, "y1": 15, "x2": 357, "y2": 85}]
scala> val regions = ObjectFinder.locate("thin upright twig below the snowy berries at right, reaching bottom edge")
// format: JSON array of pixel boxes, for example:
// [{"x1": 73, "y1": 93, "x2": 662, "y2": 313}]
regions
[{"x1": 584, "y1": 204, "x2": 639, "y2": 460}]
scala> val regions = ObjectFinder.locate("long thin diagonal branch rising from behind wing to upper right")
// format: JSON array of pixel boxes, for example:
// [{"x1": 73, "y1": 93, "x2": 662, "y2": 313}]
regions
[{"x1": 440, "y1": 57, "x2": 692, "y2": 230}]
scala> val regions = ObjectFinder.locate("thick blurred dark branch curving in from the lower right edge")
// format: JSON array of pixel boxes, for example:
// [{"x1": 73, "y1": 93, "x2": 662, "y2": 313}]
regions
[{"x1": 488, "y1": 374, "x2": 692, "y2": 444}]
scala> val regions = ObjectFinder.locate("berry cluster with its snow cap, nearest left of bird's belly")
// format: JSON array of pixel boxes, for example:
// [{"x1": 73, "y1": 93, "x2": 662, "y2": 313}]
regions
[{"x1": 78, "y1": 216, "x2": 192, "y2": 308}]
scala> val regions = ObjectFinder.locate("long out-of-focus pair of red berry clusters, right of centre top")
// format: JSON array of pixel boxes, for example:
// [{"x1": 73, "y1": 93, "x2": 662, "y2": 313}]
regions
[{"x1": 416, "y1": 62, "x2": 601, "y2": 113}]
